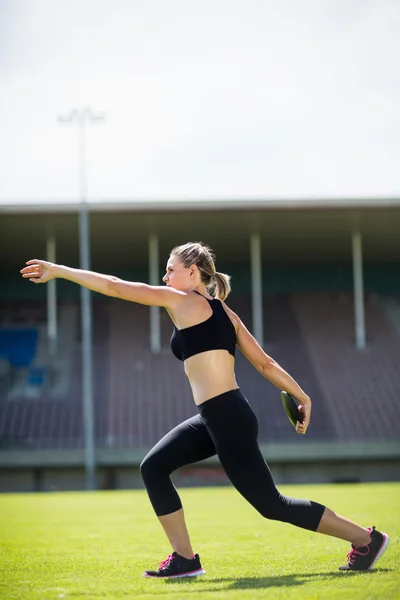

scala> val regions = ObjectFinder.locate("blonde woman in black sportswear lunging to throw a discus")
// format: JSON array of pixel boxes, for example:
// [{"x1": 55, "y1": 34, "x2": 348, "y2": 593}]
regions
[{"x1": 21, "y1": 242, "x2": 389, "y2": 578}]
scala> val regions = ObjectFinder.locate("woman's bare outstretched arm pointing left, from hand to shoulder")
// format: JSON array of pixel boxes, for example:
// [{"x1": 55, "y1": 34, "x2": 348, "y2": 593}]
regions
[{"x1": 20, "y1": 259, "x2": 185, "y2": 307}]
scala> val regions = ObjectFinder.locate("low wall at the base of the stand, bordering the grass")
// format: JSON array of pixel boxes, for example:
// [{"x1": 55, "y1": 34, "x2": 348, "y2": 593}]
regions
[{"x1": 0, "y1": 442, "x2": 400, "y2": 492}]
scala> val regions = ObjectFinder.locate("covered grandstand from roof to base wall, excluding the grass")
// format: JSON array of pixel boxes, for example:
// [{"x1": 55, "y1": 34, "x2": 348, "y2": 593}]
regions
[{"x1": 0, "y1": 199, "x2": 400, "y2": 491}]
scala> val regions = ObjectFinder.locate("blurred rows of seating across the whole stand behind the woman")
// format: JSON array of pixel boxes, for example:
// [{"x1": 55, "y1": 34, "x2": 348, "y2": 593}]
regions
[{"x1": 0, "y1": 294, "x2": 400, "y2": 449}]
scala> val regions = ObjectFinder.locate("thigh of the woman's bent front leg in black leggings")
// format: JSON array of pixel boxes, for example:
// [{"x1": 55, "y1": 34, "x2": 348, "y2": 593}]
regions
[{"x1": 144, "y1": 415, "x2": 216, "y2": 473}]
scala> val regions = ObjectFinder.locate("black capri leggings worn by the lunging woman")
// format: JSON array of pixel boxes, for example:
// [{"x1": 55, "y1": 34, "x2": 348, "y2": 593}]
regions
[{"x1": 140, "y1": 389, "x2": 325, "y2": 531}]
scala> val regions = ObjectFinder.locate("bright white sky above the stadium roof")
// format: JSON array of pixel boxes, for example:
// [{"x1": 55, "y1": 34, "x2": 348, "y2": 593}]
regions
[{"x1": 0, "y1": 0, "x2": 400, "y2": 204}]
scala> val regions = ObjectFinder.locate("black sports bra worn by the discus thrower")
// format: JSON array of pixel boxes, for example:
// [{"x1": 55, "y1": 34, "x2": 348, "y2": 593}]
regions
[{"x1": 171, "y1": 292, "x2": 236, "y2": 360}]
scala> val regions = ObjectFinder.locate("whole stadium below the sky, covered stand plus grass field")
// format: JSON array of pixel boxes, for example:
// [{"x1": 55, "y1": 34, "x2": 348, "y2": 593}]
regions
[{"x1": 0, "y1": 199, "x2": 400, "y2": 600}]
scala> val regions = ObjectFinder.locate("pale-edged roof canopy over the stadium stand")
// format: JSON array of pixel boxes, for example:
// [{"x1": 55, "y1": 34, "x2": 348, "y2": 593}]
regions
[{"x1": 0, "y1": 198, "x2": 400, "y2": 270}]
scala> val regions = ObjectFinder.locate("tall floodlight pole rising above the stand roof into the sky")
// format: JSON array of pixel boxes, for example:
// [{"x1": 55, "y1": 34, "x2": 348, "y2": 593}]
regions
[{"x1": 59, "y1": 108, "x2": 104, "y2": 490}]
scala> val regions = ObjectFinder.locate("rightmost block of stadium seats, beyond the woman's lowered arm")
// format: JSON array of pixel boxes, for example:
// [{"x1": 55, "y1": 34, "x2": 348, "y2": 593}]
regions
[{"x1": 292, "y1": 294, "x2": 400, "y2": 440}]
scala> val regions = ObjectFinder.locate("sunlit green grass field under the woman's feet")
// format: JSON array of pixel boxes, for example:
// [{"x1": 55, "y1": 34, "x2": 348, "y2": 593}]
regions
[{"x1": 0, "y1": 483, "x2": 400, "y2": 600}]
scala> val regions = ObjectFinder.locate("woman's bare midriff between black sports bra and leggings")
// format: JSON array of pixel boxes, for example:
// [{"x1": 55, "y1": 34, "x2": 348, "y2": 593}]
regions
[{"x1": 184, "y1": 350, "x2": 238, "y2": 405}]
